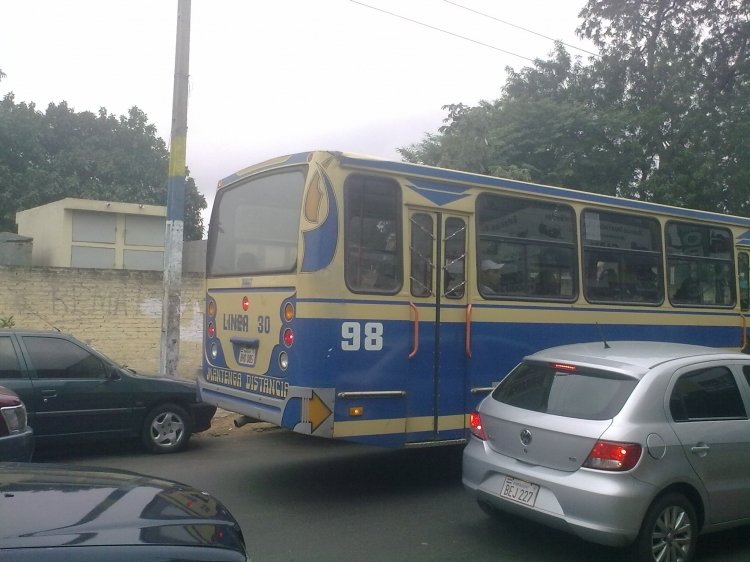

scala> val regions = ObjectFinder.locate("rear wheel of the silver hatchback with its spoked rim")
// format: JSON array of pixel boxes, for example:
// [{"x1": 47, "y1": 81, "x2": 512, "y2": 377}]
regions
[{"x1": 633, "y1": 494, "x2": 698, "y2": 562}]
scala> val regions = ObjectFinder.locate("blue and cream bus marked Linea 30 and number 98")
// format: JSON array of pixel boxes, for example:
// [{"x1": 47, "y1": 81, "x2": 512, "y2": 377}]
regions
[{"x1": 198, "y1": 151, "x2": 750, "y2": 447}]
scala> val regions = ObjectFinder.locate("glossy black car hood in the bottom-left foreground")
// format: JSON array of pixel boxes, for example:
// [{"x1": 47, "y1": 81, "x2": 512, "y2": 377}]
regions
[{"x1": 0, "y1": 463, "x2": 245, "y2": 558}]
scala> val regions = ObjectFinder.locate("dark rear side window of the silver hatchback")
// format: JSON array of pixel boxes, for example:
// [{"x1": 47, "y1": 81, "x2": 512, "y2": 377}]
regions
[{"x1": 669, "y1": 367, "x2": 747, "y2": 422}]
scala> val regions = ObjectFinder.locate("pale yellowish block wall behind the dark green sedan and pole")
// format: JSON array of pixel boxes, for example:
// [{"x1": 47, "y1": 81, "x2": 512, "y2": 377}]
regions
[{"x1": 0, "y1": 266, "x2": 205, "y2": 379}]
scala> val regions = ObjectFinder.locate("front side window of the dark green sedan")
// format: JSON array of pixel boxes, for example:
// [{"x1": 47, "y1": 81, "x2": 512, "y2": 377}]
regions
[{"x1": 23, "y1": 336, "x2": 107, "y2": 379}]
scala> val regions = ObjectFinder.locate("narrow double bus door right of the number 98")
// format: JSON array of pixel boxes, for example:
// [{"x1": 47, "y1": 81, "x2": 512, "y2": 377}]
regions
[{"x1": 406, "y1": 210, "x2": 469, "y2": 445}]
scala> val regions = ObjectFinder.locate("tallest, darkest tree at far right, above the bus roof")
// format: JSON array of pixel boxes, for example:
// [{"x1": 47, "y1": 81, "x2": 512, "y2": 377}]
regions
[{"x1": 580, "y1": 0, "x2": 750, "y2": 214}]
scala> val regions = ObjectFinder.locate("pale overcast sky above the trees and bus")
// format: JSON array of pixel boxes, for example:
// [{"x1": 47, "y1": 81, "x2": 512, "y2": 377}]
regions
[{"x1": 0, "y1": 0, "x2": 591, "y2": 230}]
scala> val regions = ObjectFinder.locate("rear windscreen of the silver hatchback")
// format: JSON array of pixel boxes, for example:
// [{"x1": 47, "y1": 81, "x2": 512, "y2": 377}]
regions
[{"x1": 492, "y1": 363, "x2": 638, "y2": 420}]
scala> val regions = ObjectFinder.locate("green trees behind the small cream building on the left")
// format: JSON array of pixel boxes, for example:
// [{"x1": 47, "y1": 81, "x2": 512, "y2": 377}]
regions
[{"x1": 0, "y1": 93, "x2": 207, "y2": 236}]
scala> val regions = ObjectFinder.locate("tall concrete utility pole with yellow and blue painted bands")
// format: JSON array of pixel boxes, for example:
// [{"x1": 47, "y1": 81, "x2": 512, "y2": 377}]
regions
[{"x1": 161, "y1": 0, "x2": 190, "y2": 377}]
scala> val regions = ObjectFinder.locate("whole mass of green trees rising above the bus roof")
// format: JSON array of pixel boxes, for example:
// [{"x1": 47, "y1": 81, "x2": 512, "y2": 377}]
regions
[{"x1": 399, "y1": 0, "x2": 750, "y2": 214}]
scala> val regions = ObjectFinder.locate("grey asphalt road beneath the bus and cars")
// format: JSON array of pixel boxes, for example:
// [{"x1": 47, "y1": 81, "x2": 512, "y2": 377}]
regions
[{"x1": 33, "y1": 420, "x2": 750, "y2": 562}]
